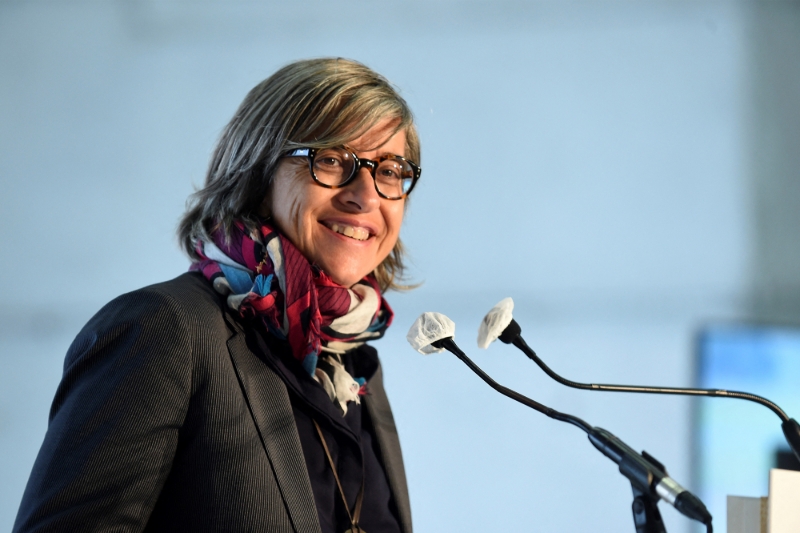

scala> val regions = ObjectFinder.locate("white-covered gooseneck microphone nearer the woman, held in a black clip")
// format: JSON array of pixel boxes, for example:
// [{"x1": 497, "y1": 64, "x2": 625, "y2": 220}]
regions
[{"x1": 408, "y1": 313, "x2": 712, "y2": 533}]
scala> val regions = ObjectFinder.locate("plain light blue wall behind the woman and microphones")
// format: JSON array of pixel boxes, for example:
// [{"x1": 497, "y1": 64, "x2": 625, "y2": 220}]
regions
[{"x1": 0, "y1": 0, "x2": 791, "y2": 533}]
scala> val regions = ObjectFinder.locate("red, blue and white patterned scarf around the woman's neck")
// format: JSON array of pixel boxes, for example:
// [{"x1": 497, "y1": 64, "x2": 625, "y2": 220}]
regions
[{"x1": 190, "y1": 218, "x2": 393, "y2": 414}]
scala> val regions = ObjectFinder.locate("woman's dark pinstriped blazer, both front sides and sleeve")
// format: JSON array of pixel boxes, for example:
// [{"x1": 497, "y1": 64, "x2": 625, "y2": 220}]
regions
[{"x1": 14, "y1": 273, "x2": 411, "y2": 533}]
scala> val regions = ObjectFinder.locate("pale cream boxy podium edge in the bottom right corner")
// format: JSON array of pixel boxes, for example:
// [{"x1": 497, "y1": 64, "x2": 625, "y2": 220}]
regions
[{"x1": 727, "y1": 468, "x2": 800, "y2": 533}]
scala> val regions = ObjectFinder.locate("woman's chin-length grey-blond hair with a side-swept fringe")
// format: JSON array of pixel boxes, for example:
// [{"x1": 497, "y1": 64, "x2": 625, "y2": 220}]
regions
[{"x1": 178, "y1": 58, "x2": 420, "y2": 291}]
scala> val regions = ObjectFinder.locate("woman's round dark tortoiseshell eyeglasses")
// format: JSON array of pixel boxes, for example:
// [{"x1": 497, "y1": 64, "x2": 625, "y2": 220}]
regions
[{"x1": 286, "y1": 147, "x2": 422, "y2": 200}]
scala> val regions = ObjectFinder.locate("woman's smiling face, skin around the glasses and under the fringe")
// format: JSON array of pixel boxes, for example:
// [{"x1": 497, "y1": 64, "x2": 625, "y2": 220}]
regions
[{"x1": 266, "y1": 120, "x2": 406, "y2": 287}]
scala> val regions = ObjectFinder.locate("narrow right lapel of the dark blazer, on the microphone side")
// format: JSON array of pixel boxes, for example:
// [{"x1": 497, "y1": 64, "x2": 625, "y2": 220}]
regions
[{"x1": 364, "y1": 367, "x2": 411, "y2": 533}]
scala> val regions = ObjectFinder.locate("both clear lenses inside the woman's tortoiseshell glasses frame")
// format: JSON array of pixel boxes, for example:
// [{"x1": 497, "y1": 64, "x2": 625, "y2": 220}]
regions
[{"x1": 312, "y1": 148, "x2": 414, "y2": 198}]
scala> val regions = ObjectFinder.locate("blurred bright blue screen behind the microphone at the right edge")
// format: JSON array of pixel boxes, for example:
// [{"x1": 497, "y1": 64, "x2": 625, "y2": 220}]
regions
[{"x1": 695, "y1": 324, "x2": 800, "y2": 531}]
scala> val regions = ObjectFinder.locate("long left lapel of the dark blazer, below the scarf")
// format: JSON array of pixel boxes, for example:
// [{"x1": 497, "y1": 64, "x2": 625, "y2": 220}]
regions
[{"x1": 227, "y1": 325, "x2": 321, "y2": 533}]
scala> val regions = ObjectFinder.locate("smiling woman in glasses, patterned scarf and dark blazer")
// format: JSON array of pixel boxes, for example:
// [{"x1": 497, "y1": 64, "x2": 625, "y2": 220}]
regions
[{"x1": 14, "y1": 59, "x2": 420, "y2": 533}]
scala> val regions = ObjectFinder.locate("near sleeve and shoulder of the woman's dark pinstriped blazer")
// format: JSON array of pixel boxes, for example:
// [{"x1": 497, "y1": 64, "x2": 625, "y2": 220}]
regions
[{"x1": 14, "y1": 275, "x2": 225, "y2": 532}]
